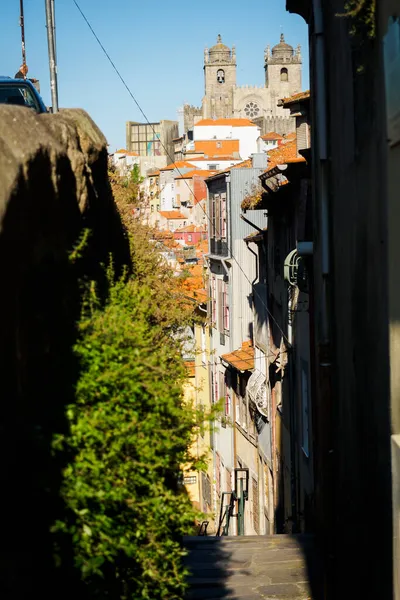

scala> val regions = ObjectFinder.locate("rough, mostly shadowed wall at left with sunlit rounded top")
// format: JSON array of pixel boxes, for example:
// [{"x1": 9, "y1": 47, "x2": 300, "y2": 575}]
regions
[{"x1": 0, "y1": 106, "x2": 128, "y2": 599}]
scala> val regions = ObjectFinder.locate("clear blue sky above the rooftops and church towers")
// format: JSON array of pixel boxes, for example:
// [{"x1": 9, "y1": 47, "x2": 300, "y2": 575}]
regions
[{"x1": 0, "y1": 0, "x2": 308, "y2": 151}]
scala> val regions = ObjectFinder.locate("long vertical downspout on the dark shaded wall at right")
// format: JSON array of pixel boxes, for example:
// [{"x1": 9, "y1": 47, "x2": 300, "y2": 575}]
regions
[{"x1": 311, "y1": 0, "x2": 335, "y2": 584}]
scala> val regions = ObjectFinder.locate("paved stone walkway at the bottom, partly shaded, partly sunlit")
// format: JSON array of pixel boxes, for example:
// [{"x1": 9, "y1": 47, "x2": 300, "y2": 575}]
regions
[{"x1": 185, "y1": 535, "x2": 321, "y2": 600}]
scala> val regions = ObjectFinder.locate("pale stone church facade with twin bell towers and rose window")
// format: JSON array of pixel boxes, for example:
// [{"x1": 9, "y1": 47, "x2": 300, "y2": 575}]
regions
[{"x1": 183, "y1": 34, "x2": 302, "y2": 134}]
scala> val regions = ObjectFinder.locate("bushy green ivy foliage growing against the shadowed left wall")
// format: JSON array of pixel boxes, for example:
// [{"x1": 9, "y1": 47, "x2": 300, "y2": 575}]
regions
[{"x1": 53, "y1": 171, "x2": 208, "y2": 600}]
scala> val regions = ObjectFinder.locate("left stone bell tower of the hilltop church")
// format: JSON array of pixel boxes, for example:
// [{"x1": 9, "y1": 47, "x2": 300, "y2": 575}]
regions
[{"x1": 202, "y1": 35, "x2": 236, "y2": 119}]
